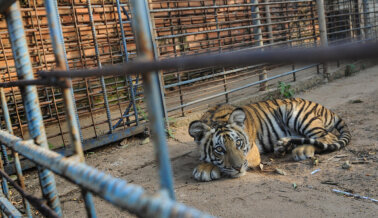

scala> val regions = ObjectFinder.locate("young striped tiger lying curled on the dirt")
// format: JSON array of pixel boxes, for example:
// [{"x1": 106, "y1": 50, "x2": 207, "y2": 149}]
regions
[{"x1": 189, "y1": 98, "x2": 351, "y2": 181}]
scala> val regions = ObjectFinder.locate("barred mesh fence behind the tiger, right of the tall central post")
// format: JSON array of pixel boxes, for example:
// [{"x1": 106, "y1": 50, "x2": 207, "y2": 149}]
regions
[{"x1": 150, "y1": 0, "x2": 376, "y2": 117}]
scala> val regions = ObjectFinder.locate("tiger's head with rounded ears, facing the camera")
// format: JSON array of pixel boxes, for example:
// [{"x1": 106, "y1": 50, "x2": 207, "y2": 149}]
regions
[{"x1": 189, "y1": 108, "x2": 251, "y2": 177}]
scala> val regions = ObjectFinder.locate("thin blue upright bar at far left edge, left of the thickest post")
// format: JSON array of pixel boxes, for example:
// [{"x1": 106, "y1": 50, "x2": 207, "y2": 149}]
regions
[{"x1": 0, "y1": 88, "x2": 32, "y2": 217}]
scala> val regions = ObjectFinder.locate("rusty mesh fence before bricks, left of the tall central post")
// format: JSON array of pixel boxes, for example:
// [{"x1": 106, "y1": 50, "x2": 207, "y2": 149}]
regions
[{"x1": 0, "y1": 0, "x2": 145, "y2": 151}]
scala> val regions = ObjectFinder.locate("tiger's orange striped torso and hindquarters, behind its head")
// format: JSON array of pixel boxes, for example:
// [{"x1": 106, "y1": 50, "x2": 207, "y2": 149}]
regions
[{"x1": 242, "y1": 98, "x2": 351, "y2": 152}]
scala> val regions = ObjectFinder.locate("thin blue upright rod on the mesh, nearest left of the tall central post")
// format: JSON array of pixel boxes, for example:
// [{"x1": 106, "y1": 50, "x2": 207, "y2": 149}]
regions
[{"x1": 117, "y1": 0, "x2": 139, "y2": 125}]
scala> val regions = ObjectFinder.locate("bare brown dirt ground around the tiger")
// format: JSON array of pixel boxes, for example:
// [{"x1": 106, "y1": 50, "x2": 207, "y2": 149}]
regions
[{"x1": 27, "y1": 67, "x2": 378, "y2": 217}]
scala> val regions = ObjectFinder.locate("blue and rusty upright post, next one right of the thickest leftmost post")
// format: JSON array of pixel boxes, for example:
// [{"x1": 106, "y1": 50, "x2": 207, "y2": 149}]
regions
[{"x1": 45, "y1": 0, "x2": 96, "y2": 217}]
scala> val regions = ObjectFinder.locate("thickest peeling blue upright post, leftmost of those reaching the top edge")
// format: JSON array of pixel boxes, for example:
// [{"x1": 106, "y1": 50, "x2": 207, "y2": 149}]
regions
[{"x1": 5, "y1": 2, "x2": 62, "y2": 216}]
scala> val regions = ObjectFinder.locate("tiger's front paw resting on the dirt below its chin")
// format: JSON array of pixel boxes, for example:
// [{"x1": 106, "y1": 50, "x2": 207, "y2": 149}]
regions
[{"x1": 193, "y1": 163, "x2": 221, "y2": 182}]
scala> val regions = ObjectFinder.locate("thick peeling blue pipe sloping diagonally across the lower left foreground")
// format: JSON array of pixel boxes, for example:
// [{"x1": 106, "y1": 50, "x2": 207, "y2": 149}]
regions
[{"x1": 0, "y1": 130, "x2": 214, "y2": 218}]
